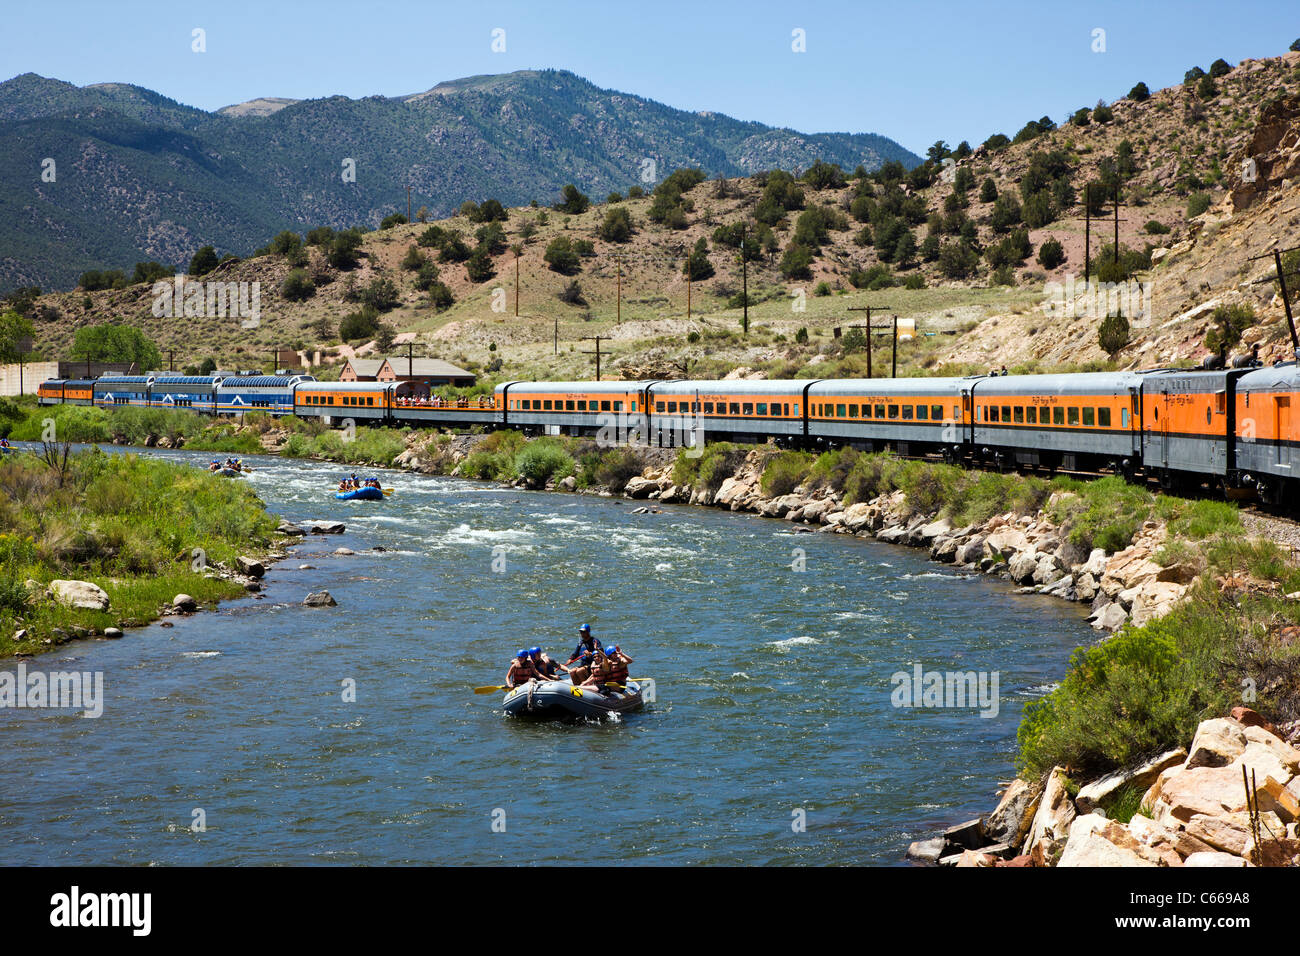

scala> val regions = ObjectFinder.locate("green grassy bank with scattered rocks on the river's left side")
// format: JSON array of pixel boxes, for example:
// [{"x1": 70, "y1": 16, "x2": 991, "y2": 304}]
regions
[{"x1": 0, "y1": 447, "x2": 277, "y2": 656}]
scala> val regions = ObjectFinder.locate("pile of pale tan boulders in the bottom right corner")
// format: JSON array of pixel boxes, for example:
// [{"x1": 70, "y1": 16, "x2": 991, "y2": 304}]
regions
[{"x1": 907, "y1": 706, "x2": 1300, "y2": 868}]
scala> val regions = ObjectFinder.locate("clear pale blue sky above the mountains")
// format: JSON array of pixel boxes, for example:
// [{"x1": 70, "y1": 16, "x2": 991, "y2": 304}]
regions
[{"x1": 0, "y1": 0, "x2": 1300, "y2": 153}]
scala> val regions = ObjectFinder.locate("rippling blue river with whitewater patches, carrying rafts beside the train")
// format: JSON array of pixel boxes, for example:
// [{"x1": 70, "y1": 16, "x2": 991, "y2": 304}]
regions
[{"x1": 0, "y1": 450, "x2": 1096, "y2": 865}]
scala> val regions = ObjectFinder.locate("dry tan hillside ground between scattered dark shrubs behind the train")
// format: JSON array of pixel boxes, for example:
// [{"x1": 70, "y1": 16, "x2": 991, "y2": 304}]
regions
[{"x1": 15, "y1": 53, "x2": 1300, "y2": 390}]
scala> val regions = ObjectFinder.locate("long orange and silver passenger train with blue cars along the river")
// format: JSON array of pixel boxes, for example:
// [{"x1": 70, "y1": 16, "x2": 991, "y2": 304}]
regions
[{"x1": 39, "y1": 362, "x2": 1300, "y2": 503}]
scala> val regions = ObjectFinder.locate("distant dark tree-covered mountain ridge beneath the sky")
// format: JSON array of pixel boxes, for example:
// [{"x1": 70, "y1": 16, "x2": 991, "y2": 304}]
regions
[{"x1": 0, "y1": 70, "x2": 919, "y2": 291}]
